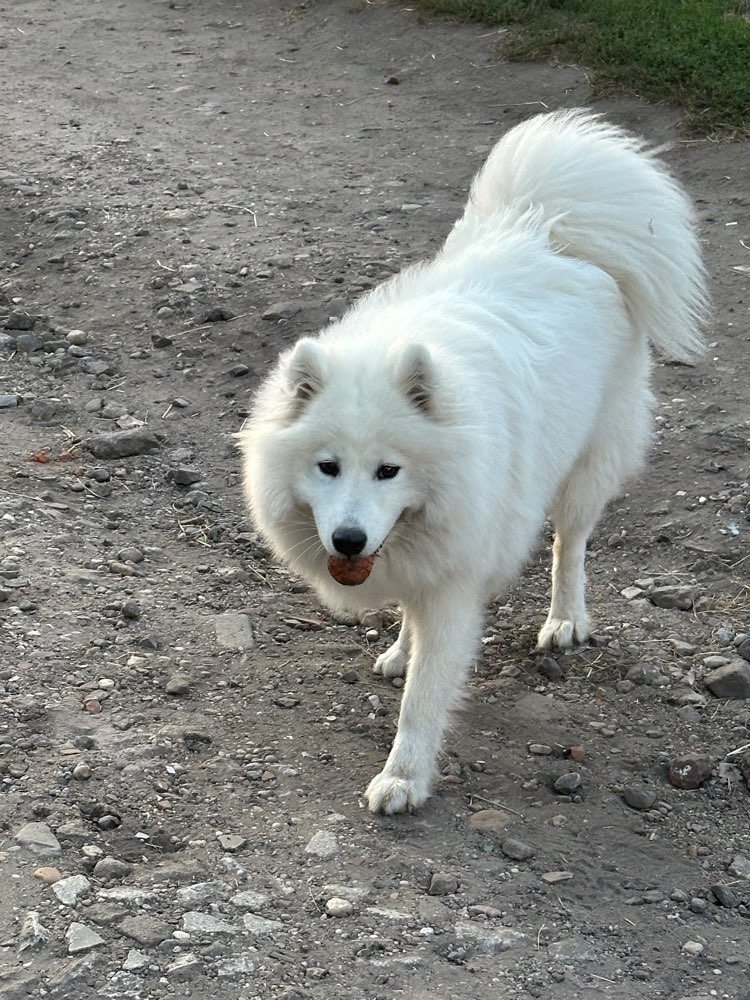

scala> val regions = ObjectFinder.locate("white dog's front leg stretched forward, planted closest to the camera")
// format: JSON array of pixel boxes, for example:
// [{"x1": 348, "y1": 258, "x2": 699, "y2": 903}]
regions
[{"x1": 365, "y1": 585, "x2": 483, "y2": 813}]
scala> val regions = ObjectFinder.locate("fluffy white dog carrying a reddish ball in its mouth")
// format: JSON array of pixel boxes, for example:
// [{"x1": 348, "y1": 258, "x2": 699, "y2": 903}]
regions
[{"x1": 241, "y1": 111, "x2": 707, "y2": 813}]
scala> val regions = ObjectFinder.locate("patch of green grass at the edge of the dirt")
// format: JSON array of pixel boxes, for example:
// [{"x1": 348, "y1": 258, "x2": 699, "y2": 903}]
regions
[{"x1": 417, "y1": 0, "x2": 750, "y2": 136}]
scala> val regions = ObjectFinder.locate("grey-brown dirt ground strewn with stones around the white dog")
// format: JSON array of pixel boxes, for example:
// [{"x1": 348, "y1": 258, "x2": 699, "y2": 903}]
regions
[{"x1": 0, "y1": 0, "x2": 750, "y2": 1000}]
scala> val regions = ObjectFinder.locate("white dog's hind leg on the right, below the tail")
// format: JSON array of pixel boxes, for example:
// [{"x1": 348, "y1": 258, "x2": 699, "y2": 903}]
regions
[{"x1": 537, "y1": 345, "x2": 651, "y2": 649}]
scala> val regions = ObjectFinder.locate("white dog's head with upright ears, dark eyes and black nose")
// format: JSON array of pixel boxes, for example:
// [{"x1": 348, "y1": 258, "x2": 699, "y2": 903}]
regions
[{"x1": 268, "y1": 339, "x2": 436, "y2": 557}]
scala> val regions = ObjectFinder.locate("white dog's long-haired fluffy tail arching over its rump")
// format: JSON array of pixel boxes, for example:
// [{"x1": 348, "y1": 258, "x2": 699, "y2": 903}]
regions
[{"x1": 446, "y1": 110, "x2": 708, "y2": 361}]
